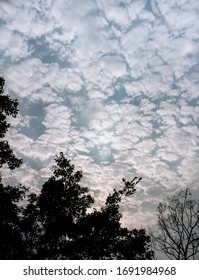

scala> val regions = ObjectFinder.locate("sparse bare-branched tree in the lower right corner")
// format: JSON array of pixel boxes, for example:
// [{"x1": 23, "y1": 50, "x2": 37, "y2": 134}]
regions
[{"x1": 151, "y1": 188, "x2": 199, "y2": 260}]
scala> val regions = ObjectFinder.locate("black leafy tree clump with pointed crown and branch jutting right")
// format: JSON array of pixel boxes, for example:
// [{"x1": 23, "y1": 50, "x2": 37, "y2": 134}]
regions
[{"x1": 21, "y1": 153, "x2": 153, "y2": 260}]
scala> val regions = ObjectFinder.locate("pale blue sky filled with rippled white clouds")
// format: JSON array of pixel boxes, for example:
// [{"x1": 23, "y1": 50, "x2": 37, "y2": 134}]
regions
[{"x1": 0, "y1": 0, "x2": 199, "y2": 238}]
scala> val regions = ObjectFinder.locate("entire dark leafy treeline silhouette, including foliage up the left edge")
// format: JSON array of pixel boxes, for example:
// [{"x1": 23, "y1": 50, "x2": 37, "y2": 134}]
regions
[{"x1": 0, "y1": 78, "x2": 154, "y2": 260}]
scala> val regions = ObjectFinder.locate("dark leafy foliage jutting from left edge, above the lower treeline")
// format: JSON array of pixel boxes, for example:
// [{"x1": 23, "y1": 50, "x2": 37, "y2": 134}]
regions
[{"x1": 0, "y1": 77, "x2": 22, "y2": 173}]
